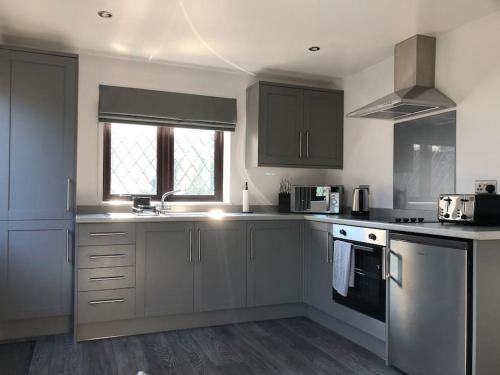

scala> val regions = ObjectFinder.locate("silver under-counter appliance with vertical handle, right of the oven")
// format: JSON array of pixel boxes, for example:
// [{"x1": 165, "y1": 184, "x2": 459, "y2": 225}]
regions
[{"x1": 386, "y1": 233, "x2": 472, "y2": 375}]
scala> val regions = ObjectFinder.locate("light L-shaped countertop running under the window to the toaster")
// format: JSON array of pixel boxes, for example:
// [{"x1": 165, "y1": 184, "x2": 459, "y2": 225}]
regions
[{"x1": 76, "y1": 212, "x2": 500, "y2": 240}]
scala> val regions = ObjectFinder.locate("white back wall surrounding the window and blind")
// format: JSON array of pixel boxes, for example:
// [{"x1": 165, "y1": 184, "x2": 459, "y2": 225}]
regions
[{"x1": 77, "y1": 55, "x2": 335, "y2": 205}]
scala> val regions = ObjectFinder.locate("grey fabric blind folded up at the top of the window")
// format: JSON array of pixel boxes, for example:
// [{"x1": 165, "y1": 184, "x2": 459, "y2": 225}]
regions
[{"x1": 99, "y1": 85, "x2": 236, "y2": 131}]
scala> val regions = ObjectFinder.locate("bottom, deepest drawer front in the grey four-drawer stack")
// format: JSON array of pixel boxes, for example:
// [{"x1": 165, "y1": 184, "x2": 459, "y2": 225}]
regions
[{"x1": 78, "y1": 288, "x2": 135, "y2": 324}]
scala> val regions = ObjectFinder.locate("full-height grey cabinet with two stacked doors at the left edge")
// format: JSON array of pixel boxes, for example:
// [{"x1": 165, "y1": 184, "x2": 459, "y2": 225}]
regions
[{"x1": 0, "y1": 47, "x2": 77, "y2": 338}]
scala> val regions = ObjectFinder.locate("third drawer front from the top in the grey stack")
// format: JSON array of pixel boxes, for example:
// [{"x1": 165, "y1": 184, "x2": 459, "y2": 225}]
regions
[{"x1": 78, "y1": 266, "x2": 135, "y2": 291}]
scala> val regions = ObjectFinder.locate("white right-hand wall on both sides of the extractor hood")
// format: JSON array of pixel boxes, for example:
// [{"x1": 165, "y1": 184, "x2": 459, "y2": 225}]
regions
[{"x1": 329, "y1": 12, "x2": 500, "y2": 208}]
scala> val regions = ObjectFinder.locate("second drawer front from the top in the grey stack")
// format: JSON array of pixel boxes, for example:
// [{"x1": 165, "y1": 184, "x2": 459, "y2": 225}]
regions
[{"x1": 78, "y1": 245, "x2": 135, "y2": 268}]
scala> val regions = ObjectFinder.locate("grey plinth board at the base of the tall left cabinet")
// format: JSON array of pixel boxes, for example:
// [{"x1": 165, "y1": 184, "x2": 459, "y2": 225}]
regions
[{"x1": 0, "y1": 315, "x2": 72, "y2": 342}]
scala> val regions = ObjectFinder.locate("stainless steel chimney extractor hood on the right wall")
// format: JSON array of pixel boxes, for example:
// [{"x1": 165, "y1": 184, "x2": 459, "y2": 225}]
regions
[{"x1": 347, "y1": 35, "x2": 456, "y2": 120}]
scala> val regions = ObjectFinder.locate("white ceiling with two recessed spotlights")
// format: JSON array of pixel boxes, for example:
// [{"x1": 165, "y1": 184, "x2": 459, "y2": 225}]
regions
[{"x1": 0, "y1": 0, "x2": 500, "y2": 78}]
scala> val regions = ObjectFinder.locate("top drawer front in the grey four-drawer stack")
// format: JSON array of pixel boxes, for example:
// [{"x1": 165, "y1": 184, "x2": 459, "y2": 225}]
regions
[{"x1": 78, "y1": 223, "x2": 135, "y2": 246}]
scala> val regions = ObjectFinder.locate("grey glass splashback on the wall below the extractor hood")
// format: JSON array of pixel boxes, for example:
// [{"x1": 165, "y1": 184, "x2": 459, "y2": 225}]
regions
[{"x1": 394, "y1": 111, "x2": 456, "y2": 210}]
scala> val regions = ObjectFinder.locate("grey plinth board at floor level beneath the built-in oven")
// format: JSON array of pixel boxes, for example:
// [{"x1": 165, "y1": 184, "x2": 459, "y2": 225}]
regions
[{"x1": 305, "y1": 306, "x2": 386, "y2": 359}]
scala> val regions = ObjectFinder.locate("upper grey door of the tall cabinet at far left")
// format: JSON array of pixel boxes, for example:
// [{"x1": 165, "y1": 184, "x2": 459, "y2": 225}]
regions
[{"x1": 8, "y1": 51, "x2": 76, "y2": 220}]
